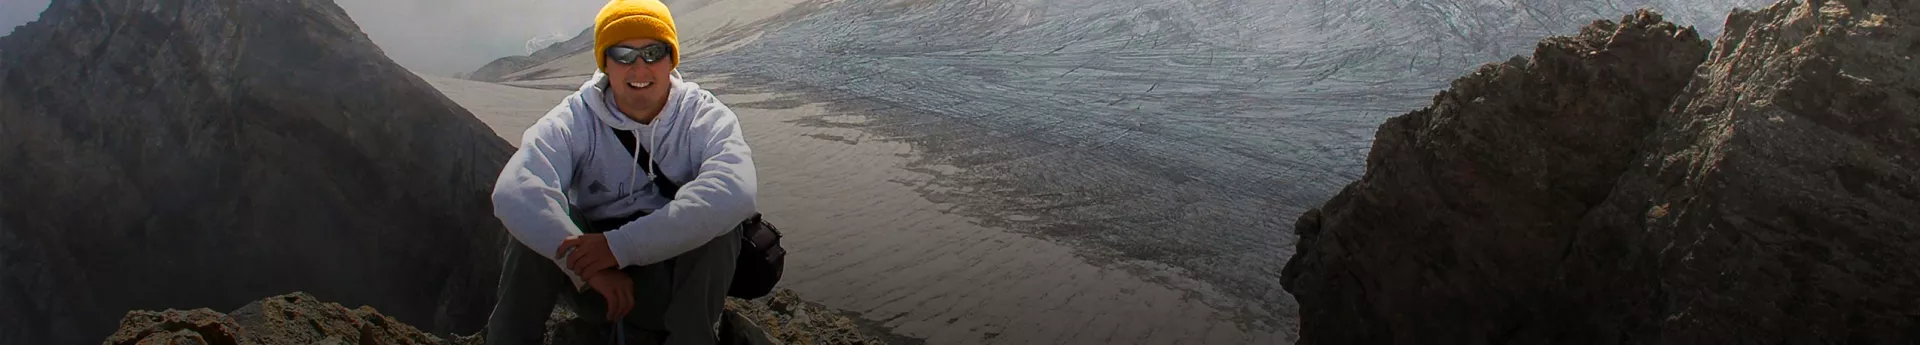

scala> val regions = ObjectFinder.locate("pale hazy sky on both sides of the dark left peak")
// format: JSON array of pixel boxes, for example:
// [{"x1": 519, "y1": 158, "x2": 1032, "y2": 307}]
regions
[{"x1": 0, "y1": 0, "x2": 607, "y2": 75}]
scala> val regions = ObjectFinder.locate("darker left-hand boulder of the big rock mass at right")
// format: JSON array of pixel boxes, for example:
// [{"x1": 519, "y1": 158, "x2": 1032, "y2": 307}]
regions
[{"x1": 1283, "y1": 12, "x2": 1707, "y2": 343}]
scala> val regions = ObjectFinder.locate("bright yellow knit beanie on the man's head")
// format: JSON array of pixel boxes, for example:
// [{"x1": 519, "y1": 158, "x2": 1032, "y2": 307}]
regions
[{"x1": 593, "y1": 0, "x2": 680, "y2": 71}]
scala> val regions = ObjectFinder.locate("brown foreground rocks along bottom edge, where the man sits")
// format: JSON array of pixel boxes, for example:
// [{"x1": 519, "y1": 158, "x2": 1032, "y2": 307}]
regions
[{"x1": 104, "y1": 289, "x2": 879, "y2": 345}]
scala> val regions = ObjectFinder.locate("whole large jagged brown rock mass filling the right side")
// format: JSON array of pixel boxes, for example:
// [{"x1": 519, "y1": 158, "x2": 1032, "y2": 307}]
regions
[{"x1": 1283, "y1": 0, "x2": 1920, "y2": 343}]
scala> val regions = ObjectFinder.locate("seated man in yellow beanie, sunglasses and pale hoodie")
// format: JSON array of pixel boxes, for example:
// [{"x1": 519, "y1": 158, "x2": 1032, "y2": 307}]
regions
[{"x1": 488, "y1": 0, "x2": 756, "y2": 345}]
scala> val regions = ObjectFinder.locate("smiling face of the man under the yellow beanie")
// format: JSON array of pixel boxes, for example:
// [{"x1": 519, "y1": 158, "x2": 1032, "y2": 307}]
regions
[{"x1": 601, "y1": 38, "x2": 674, "y2": 121}]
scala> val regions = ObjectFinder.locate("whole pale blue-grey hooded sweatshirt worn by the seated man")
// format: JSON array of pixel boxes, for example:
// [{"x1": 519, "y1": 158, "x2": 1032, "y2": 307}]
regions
[{"x1": 493, "y1": 71, "x2": 758, "y2": 289}]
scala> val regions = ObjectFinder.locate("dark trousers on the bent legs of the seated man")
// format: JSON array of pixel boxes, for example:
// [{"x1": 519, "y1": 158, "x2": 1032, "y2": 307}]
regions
[{"x1": 486, "y1": 219, "x2": 741, "y2": 345}]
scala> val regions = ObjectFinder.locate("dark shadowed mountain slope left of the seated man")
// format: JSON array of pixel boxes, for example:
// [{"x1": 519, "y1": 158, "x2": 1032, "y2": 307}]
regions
[{"x1": 0, "y1": 0, "x2": 511, "y2": 343}]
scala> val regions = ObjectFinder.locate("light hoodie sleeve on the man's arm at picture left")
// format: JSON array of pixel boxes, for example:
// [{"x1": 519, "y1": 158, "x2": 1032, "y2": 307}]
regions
[{"x1": 493, "y1": 104, "x2": 586, "y2": 289}]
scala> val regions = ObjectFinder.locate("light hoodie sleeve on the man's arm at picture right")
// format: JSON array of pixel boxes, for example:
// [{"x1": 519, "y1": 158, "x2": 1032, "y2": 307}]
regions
[{"x1": 607, "y1": 92, "x2": 758, "y2": 266}]
